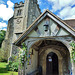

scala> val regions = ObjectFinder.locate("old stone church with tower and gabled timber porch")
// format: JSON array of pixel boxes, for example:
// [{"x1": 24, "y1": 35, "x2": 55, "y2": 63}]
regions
[{"x1": 2, "y1": 0, "x2": 75, "y2": 75}]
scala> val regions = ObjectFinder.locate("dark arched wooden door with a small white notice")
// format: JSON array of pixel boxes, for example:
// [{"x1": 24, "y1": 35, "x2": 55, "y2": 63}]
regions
[{"x1": 46, "y1": 52, "x2": 58, "y2": 75}]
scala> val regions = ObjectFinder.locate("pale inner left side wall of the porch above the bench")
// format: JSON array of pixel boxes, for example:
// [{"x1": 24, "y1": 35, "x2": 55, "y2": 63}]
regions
[{"x1": 18, "y1": 48, "x2": 38, "y2": 75}]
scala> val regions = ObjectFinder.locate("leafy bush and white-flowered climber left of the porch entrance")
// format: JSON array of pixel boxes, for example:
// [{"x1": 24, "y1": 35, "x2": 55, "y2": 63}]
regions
[{"x1": 7, "y1": 43, "x2": 28, "y2": 72}]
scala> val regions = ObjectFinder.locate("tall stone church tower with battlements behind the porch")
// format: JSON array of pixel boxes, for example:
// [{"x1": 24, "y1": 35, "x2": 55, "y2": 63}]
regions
[{"x1": 2, "y1": 0, "x2": 41, "y2": 57}]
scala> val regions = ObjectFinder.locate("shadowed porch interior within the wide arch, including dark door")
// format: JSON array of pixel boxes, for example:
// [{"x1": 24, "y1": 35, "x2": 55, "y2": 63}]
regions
[{"x1": 26, "y1": 40, "x2": 72, "y2": 75}]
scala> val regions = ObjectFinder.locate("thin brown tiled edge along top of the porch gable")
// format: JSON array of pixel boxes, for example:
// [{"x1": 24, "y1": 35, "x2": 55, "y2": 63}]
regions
[{"x1": 14, "y1": 9, "x2": 75, "y2": 44}]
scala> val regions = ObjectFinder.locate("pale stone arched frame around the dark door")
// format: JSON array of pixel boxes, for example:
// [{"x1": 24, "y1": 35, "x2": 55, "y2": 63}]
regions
[{"x1": 39, "y1": 48, "x2": 63, "y2": 75}]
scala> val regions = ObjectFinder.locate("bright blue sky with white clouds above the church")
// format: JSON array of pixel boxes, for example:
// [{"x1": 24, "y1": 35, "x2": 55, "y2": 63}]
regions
[{"x1": 0, "y1": 0, "x2": 75, "y2": 30}]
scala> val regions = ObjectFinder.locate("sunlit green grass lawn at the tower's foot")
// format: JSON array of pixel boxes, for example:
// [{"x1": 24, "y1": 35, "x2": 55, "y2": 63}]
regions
[{"x1": 0, "y1": 62, "x2": 18, "y2": 75}]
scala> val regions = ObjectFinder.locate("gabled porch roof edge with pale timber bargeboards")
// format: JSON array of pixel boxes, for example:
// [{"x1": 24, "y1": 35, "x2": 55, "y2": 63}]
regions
[{"x1": 14, "y1": 10, "x2": 75, "y2": 45}]
